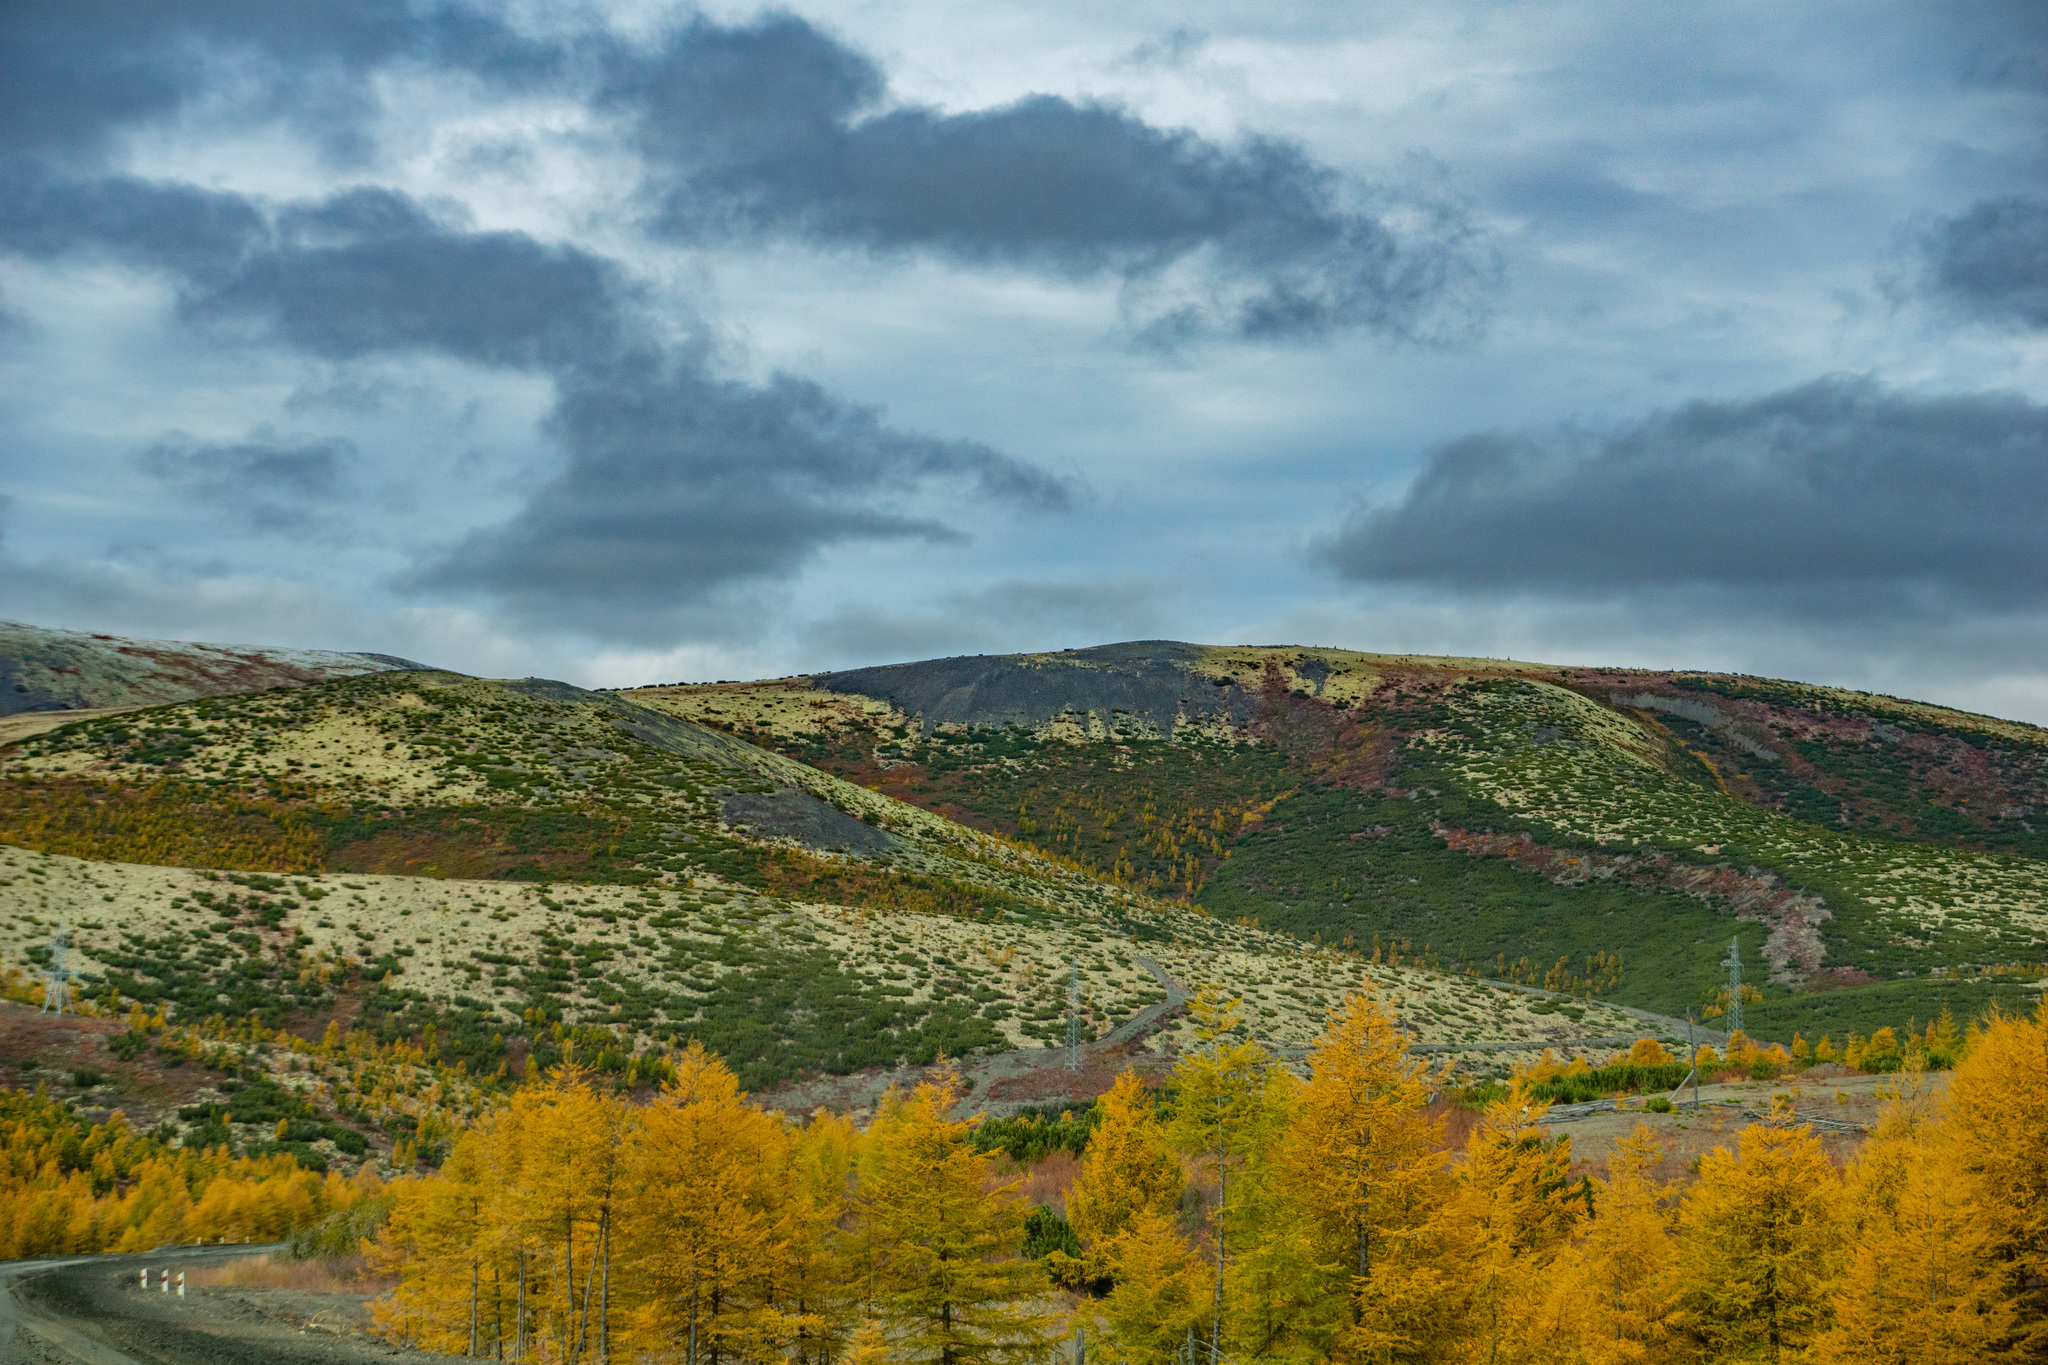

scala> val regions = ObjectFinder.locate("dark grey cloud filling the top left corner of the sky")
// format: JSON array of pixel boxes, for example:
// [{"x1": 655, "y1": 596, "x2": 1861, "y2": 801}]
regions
[{"x1": 0, "y1": 0, "x2": 565, "y2": 160}]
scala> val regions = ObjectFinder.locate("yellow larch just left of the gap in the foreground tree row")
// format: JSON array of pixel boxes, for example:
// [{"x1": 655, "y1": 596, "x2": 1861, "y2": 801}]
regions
[{"x1": 852, "y1": 1070, "x2": 1049, "y2": 1365}]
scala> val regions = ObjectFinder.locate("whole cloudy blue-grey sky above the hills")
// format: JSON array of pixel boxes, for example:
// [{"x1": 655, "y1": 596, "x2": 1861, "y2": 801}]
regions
[{"x1": 0, "y1": 0, "x2": 2048, "y2": 722}]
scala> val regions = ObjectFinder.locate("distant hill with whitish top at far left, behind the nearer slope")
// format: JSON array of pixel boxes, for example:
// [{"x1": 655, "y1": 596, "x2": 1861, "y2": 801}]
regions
[{"x1": 0, "y1": 620, "x2": 426, "y2": 716}]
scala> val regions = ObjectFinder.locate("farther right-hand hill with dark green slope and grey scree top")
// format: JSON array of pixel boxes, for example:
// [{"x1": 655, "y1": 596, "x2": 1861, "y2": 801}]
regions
[{"x1": 621, "y1": 643, "x2": 2048, "y2": 1040}]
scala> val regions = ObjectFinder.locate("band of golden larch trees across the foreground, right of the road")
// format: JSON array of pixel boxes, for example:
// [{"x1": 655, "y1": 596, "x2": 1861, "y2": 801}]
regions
[{"x1": 360, "y1": 990, "x2": 2048, "y2": 1365}]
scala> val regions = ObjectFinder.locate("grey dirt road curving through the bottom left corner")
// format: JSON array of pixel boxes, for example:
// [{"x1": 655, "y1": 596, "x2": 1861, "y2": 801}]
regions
[{"x1": 0, "y1": 1246, "x2": 446, "y2": 1365}]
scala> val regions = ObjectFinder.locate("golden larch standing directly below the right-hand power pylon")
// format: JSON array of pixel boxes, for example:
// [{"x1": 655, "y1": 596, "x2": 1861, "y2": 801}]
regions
[{"x1": 1673, "y1": 1124, "x2": 1841, "y2": 1365}]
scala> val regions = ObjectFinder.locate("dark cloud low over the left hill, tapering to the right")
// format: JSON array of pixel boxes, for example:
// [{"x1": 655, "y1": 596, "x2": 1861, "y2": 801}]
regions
[{"x1": 414, "y1": 354, "x2": 1067, "y2": 643}]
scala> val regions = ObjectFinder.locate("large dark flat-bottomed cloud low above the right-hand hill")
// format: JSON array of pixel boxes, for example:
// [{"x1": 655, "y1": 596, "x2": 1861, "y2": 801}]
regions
[{"x1": 1321, "y1": 379, "x2": 2048, "y2": 612}]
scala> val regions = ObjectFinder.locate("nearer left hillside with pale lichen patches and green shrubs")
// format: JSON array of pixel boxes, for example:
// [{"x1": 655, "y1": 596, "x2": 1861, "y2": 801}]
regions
[{"x1": 0, "y1": 671, "x2": 1679, "y2": 1160}]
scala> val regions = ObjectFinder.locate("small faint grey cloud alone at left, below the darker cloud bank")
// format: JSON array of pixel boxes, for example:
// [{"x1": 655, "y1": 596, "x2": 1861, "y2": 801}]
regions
[{"x1": 137, "y1": 428, "x2": 356, "y2": 530}]
